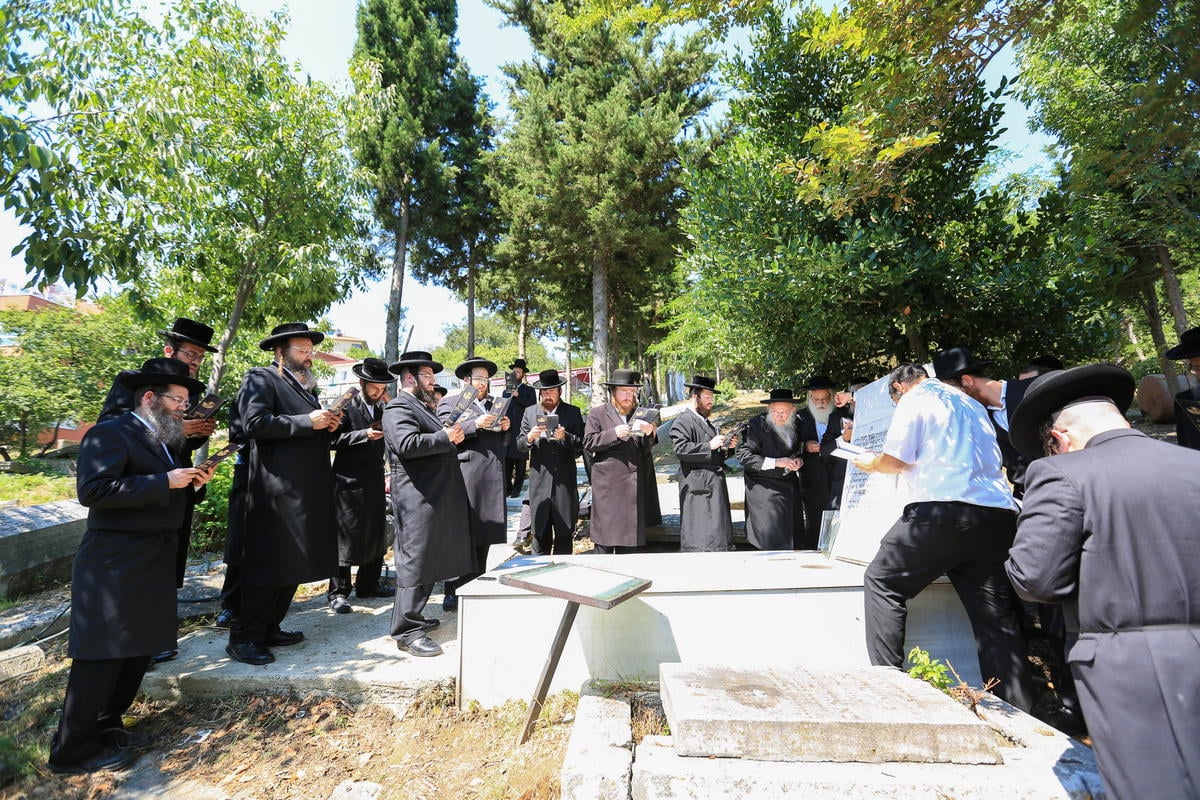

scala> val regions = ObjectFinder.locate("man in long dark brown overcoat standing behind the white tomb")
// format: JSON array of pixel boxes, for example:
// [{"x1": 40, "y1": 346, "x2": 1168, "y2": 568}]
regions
[{"x1": 583, "y1": 369, "x2": 658, "y2": 553}]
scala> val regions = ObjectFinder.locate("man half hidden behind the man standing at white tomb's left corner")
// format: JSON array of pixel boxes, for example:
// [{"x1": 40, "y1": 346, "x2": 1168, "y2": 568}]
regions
[{"x1": 438, "y1": 359, "x2": 511, "y2": 612}]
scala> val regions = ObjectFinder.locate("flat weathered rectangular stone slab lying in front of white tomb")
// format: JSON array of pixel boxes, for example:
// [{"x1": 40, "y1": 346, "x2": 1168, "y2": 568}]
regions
[{"x1": 660, "y1": 663, "x2": 1002, "y2": 764}]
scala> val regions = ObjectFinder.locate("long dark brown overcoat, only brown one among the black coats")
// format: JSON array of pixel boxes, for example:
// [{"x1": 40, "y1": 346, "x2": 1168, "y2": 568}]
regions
[{"x1": 583, "y1": 403, "x2": 658, "y2": 547}]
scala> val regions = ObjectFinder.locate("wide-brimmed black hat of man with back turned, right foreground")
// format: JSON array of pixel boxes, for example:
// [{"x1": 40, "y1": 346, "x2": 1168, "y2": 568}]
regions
[{"x1": 1008, "y1": 363, "x2": 1135, "y2": 458}]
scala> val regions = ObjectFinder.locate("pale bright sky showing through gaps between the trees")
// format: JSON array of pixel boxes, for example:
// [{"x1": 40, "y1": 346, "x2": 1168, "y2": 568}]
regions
[{"x1": 0, "y1": 0, "x2": 1048, "y2": 353}]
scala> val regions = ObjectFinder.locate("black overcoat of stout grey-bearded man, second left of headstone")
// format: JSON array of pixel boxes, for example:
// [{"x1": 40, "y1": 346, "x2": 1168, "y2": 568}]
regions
[{"x1": 737, "y1": 414, "x2": 804, "y2": 551}]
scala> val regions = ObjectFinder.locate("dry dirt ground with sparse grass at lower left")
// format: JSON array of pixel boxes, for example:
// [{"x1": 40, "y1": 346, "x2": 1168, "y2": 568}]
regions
[{"x1": 0, "y1": 623, "x2": 577, "y2": 800}]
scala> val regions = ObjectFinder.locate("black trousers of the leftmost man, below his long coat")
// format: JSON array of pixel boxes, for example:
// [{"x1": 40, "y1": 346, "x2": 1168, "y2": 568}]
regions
[{"x1": 50, "y1": 656, "x2": 150, "y2": 766}]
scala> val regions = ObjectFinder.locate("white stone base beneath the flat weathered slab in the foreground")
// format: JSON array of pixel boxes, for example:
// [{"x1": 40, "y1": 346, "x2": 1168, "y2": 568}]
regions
[{"x1": 630, "y1": 697, "x2": 1108, "y2": 800}]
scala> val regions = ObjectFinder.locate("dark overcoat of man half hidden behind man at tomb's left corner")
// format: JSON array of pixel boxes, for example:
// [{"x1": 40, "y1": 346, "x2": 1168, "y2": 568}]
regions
[{"x1": 438, "y1": 396, "x2": 511, "y2": 563}]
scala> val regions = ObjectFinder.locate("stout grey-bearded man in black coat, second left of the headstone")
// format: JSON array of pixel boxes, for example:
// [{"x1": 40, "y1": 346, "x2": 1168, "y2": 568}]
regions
[{"x1": 737, "y1": 389, "x2": 806, "y2": 551}]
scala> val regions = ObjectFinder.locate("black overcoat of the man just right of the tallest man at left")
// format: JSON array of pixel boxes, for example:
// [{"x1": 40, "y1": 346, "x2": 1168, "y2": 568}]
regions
[{"x1": 334, "y1": 395, "x2": 390, "y2": 566}]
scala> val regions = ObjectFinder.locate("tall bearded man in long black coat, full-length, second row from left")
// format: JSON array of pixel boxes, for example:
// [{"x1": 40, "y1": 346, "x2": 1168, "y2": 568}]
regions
[{"x1": 226, "y1": 323, "x2": 341, "y2": 666}]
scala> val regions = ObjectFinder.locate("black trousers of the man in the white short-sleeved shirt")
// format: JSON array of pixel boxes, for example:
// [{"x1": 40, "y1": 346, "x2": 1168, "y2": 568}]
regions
[{"x1": 864, "y1": 503, "x2": 1033, "y2": 711}]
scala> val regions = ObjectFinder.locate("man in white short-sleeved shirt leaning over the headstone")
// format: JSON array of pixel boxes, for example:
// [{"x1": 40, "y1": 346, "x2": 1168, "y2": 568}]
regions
[{"x1": 854, "y1": 365, "x2": 1033, "y2": 711}]
